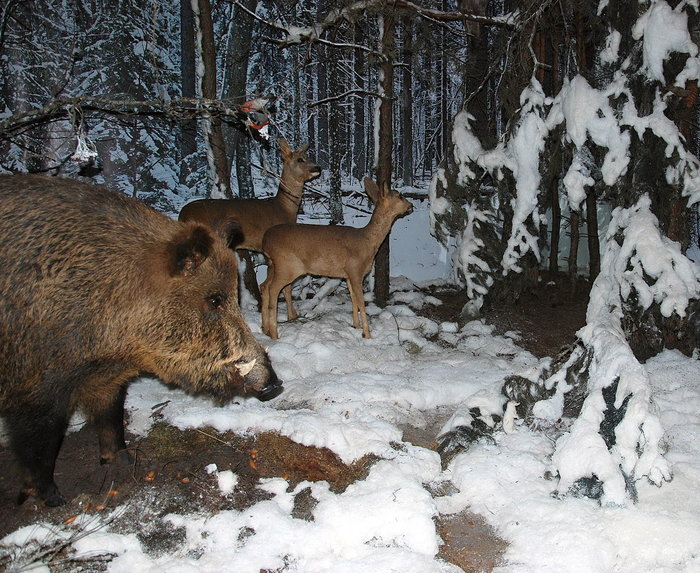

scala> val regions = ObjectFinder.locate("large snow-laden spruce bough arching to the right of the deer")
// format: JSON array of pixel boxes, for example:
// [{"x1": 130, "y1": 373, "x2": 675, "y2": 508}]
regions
[{"x1": 431, "y1": 61, "x2": 700, "y2": 290}]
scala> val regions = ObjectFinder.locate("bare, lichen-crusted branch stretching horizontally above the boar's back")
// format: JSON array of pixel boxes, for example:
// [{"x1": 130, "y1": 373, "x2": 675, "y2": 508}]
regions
[{"x1": 0, "y1": 96, "x2": 268, "y2": 139}]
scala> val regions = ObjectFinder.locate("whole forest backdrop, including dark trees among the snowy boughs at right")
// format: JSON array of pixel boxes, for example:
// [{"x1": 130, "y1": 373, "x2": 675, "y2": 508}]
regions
[{"x1": 0, "y1": 0, "x2": 697, "y2": 286}]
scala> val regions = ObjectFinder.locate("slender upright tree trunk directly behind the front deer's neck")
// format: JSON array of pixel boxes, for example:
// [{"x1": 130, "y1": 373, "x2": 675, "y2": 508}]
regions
[{"x1": 374, "y1": 14, "x2": 394, "y2": 307}]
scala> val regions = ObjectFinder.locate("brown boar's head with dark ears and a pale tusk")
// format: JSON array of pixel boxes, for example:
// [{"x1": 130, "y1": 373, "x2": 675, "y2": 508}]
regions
[{"x1": 133, "y1": 219, "x2": 282, "y2": 402}]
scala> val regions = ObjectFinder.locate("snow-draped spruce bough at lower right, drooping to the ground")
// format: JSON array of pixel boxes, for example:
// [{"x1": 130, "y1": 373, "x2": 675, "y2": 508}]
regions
[{"x1": 548, "y1": 195, "x2": 700, "y2": 503}]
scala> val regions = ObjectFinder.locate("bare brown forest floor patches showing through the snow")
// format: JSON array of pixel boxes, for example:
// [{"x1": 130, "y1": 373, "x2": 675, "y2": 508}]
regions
[{"x1": 0, "y1": 274, "x2": 588, "y2": 573}]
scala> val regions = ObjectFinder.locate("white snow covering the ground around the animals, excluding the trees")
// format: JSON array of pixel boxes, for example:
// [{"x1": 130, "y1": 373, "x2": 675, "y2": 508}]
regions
[{"x1": 2, "y1": 194, "x2": 700, "y2": 573}]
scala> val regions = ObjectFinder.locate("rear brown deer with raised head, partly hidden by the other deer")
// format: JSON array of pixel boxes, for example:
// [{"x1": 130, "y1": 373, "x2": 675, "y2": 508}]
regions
[{"x1": 178, "y1": 137, "x2": 321, "y2": 306}]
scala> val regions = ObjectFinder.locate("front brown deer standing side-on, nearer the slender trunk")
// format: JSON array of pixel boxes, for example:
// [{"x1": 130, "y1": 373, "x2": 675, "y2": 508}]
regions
[{"x1": 260, "y1": 177, "x2": 412, "y2": 338}]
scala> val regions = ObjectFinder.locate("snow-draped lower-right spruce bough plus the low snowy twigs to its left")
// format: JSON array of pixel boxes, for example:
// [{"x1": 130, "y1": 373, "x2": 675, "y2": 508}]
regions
[{"x1": 440, "y1": 195, "x2": 700, "y2": 505}]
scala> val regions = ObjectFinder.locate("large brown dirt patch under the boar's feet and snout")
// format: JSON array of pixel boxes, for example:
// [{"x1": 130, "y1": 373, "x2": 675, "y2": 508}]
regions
[{"x1": 0, "y1": 423, "x2": 375, "y2": 571}]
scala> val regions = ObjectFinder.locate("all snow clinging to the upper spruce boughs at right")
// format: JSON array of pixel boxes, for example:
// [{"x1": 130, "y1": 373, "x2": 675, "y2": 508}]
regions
[{"x1": 430, "y1": 0, "x2": 700, "y2": 292}]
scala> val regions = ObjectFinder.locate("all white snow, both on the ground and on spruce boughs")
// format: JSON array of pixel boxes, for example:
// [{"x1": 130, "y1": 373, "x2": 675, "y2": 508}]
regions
[{"x1": 0, "y1": 0, "x2": 700, "y2": 573}]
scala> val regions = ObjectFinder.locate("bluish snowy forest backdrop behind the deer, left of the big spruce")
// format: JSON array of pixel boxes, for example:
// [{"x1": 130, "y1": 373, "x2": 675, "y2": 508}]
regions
[{"x1": 0, "y1": 1, "x2": 474, "y2": 210}]
